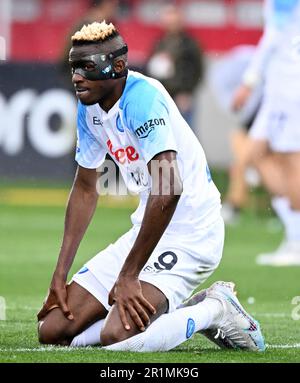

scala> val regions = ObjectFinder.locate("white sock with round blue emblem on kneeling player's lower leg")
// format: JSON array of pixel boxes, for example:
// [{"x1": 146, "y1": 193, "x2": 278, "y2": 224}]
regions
[{"x1": 103, "y1": 298, "x2": 222, "y2": 352}]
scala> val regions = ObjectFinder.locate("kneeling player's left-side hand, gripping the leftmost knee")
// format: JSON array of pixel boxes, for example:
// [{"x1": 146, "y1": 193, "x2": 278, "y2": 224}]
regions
[{"x1": 37, "y1": 281, "x2": 74, "y2": 321}]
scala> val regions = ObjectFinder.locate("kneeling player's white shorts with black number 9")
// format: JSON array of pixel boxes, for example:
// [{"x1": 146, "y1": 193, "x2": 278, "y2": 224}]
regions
[{"x1": 72, "y1": 217, "x2": 224, "y2": 312}]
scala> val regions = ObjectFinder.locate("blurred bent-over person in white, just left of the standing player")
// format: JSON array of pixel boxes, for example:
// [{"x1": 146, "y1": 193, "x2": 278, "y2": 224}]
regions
[{"x1": 208, "y1": 45, "x2": 263, "y2": 223}]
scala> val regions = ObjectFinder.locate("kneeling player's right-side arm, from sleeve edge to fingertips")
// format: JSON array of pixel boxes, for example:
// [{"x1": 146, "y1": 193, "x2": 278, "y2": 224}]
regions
[{"x1": 109, "y1": 151, "x2": 182, "y2": 331}]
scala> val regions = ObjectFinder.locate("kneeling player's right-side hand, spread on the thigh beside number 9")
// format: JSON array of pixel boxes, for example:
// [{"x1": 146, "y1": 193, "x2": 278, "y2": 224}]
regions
[{"x1": 108, "y1": 275, "x2": 156, "y2": 331}]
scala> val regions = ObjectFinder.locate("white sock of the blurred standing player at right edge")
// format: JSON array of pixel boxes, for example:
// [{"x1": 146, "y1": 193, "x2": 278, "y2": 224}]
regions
[{"x1": 272, "y1": 197, "x2": 300, "y2": 243}]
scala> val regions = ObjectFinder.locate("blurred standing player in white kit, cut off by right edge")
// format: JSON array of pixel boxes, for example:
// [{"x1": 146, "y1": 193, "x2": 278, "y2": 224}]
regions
[{"x1": 233, "y1": 0, "x2": 300, "y2": 266}]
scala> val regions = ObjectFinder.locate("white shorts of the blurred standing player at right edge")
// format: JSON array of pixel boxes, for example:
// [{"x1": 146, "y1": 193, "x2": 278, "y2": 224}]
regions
[{"x1": 250, "y1": 97, "x2": 300, "y2": 153}]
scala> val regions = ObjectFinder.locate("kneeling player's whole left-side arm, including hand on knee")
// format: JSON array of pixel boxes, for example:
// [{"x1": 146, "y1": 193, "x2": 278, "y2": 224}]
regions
[{"x1": 37, "y1": 166, "x2": 98, "y2": 320}]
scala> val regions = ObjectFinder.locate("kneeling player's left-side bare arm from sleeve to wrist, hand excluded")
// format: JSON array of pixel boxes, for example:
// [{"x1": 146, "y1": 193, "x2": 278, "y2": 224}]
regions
[{"x1": 55, "y1": 167, "x2": 98, "y2": 279}]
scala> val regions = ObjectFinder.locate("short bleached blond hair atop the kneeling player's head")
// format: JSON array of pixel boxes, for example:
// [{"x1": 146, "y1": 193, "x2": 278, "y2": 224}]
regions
[{"x1": 71, "y1": 20, "x2": 119, "y2": 43}]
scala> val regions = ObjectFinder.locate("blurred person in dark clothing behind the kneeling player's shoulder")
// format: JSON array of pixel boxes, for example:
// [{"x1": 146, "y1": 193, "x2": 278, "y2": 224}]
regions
[{"x1": 146, "y1": 4, "x2": 204, "y2": 127}]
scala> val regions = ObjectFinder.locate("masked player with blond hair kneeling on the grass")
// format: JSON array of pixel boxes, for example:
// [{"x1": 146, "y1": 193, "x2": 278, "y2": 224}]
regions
[{"x1": 38, "y1": 22, "x2": 265, "y2": 351}]
